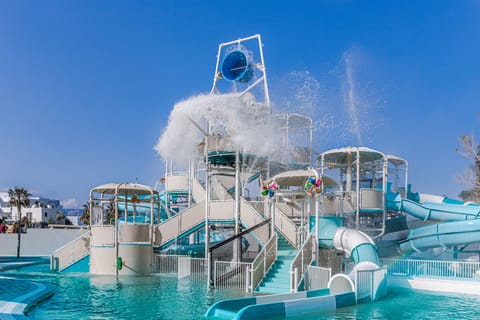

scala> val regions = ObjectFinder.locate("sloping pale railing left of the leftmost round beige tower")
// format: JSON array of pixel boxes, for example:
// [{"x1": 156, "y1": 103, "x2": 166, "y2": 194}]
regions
[{"x1": 50, "y1": 232, "x2": 90, "y2": 271}]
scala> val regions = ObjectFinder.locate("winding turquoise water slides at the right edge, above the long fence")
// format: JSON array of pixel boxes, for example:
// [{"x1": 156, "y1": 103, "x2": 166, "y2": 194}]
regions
[{"x1": 386, "y1": 193, "x2": 480, "y2": 252}]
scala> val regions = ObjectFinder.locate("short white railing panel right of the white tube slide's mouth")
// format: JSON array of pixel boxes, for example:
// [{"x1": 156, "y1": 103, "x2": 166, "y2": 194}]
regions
[{"x1": 355, "y1": 267, "x2": 387, "y2": 303}]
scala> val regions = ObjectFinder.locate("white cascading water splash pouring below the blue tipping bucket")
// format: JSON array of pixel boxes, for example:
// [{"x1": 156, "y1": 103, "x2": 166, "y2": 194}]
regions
[{"x1": 155, "y1": 94, "x2": 278, "y2": 165}]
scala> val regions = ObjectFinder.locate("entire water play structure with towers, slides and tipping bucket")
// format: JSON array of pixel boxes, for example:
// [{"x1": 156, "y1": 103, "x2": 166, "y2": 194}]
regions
[{"x1": 46, "y1": 35, "x2": 480, "y2": 319}]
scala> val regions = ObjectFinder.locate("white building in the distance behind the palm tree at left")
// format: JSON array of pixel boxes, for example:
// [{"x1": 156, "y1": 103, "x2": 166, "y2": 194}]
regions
[{"x1": 0, "y1": 192, "x2": 63, "y2": 224}]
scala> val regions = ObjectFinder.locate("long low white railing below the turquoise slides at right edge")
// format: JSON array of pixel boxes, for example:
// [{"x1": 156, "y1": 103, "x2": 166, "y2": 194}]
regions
[{"x1": 381, "y1": 259, "x2": 480, "y2": 282}]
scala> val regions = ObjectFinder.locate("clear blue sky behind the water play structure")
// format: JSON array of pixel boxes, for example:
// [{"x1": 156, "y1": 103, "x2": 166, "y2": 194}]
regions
[{"x1": 0, "y1": 0, "x2": 480, "y2": 207}]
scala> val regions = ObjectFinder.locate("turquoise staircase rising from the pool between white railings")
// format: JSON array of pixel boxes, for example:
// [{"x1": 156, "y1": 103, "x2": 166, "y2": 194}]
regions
[{"x1": 256, "y1": 234, "x2": 298, "y2": 293}]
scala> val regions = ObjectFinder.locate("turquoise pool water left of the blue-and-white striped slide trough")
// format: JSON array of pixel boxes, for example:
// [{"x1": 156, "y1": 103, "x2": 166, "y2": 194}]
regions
[{"x1": 6, "y1": 266, "x2": 246, "y2": 320}]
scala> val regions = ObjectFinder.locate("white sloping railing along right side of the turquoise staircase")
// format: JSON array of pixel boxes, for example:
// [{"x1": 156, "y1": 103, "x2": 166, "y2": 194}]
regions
[{"x1": 290, "y1": 233, "x2": 315, "y2": 292}]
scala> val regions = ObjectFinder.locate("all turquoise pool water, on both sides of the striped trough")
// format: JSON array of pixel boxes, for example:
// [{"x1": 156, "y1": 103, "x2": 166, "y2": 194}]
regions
[{"x1": 2, "y1": 266, "x2": 480, "y2": 320}]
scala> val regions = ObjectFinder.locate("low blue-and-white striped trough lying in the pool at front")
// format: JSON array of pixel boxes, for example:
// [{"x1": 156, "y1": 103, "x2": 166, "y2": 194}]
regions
[{"x1": 205, "y1": 289, "x2": 356, "y2": 320}]
